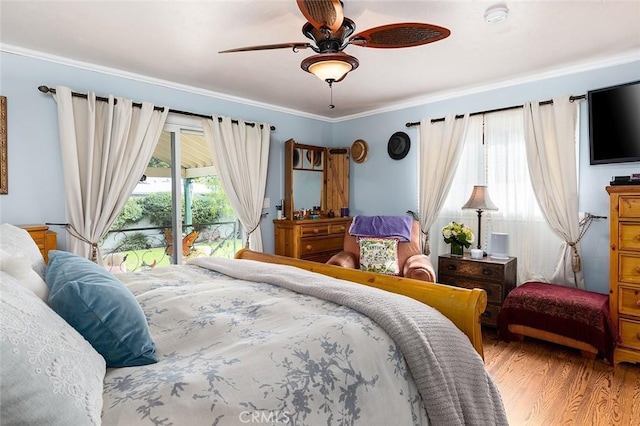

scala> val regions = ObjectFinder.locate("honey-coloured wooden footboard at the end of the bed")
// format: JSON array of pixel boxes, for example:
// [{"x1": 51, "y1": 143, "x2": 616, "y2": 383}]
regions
[{"x1": 235, "y1": 249, "x2": 487, "y2": 359}]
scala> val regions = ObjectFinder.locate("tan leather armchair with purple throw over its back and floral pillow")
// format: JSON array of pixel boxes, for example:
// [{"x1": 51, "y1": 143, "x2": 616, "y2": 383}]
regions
[{"x1": 327, "y1": 220, "x2": 436, "y2": 282}]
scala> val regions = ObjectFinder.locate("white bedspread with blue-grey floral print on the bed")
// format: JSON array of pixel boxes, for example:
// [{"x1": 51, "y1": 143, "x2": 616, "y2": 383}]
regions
[{"x1": 102, "y1": 265, "x2": 428, "y2": 426}]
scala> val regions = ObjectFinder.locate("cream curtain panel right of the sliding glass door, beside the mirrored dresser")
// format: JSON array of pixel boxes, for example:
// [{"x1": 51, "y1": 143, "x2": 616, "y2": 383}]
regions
[{"x1": 202, "y1": 115, "x2": 271, "y2": 251}]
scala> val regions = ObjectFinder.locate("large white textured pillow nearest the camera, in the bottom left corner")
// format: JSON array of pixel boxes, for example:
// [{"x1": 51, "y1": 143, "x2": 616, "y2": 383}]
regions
[{"x1": 0, "y1": 271, "x2": 106, "y2": 425}]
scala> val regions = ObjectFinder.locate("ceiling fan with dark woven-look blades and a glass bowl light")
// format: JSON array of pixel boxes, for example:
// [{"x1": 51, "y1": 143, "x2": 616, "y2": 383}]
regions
[{"x1": 218, "y1": 0, "x2": 451, "y2": 90}]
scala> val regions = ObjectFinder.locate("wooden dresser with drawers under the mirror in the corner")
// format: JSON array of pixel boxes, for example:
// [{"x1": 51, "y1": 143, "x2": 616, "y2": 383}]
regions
[{"x1": 273, "y1": 217, "x2": 351, "y2": 263}]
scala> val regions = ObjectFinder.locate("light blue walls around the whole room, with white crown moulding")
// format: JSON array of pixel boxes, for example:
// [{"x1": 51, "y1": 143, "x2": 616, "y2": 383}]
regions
[{"x1": 0, "y1": 52, "x2": 640, "y2": 293}]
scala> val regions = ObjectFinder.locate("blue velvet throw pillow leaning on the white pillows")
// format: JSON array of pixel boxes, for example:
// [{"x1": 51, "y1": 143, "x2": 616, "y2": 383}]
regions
[{"x1": 45, "y1": 250, "x2": 158, "y2": 367}]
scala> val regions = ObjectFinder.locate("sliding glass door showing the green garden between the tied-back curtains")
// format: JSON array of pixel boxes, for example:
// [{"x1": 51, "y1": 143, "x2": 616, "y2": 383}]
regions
[{"x1": 101, "y1": 120, "x2": 242, "y2": 272}]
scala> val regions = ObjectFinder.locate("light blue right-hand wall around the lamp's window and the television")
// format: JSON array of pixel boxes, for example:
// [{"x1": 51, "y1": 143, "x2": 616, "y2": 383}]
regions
[{"x1": 333, "y1": 61, "x2": 640, "y2": 293}]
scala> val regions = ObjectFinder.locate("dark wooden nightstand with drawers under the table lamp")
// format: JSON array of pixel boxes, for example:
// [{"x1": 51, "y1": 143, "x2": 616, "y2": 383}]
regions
[{"x1": 438, "y1": 254, "x2": 518, "y2": 327}]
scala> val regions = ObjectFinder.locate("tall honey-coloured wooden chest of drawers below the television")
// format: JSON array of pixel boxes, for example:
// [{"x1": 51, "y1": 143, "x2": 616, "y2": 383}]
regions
[{"x1": 607, "y1": 185, "x2": 640, "y2": 364}]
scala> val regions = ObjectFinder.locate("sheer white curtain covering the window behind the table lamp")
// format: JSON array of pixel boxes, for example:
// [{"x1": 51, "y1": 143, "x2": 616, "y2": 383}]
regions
[{"x1": 431, "y1": 109, "x2": 562, "y2": 283}]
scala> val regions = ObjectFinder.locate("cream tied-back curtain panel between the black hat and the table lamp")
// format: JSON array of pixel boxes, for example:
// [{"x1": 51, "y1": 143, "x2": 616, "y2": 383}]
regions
[{"x1": 418, "y1": 114, "x2": 469, "y2": 255}]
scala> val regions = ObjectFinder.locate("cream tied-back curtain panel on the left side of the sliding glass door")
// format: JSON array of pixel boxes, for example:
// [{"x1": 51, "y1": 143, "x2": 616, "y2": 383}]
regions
[{"x1": 54, "y1": 86, "x2": 168, "y2": 263}]
